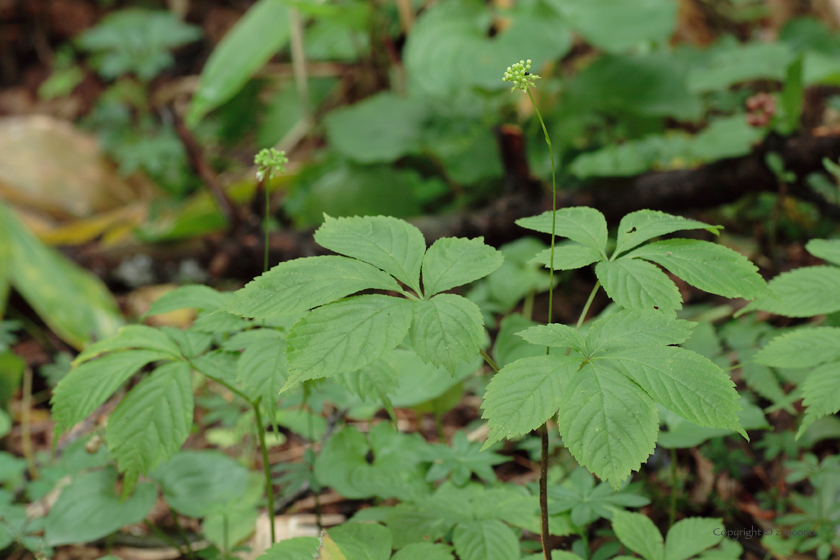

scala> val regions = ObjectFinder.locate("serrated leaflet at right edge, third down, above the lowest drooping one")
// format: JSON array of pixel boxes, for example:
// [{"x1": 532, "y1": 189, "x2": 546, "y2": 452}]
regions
[{"x1": 753, "y1": 327, "x2": 840, "y2": 368}]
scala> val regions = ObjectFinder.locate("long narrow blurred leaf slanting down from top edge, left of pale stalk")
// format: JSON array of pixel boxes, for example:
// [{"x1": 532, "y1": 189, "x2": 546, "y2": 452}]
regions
[{"x1": 186, "y1": 0, "x2": 291, "y2": 127}]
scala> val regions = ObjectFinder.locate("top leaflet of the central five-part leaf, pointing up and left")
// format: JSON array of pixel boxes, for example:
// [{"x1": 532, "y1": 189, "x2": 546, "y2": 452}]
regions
[{"x1": 315, "y1": 216, "x2": 426, "y2": 294}]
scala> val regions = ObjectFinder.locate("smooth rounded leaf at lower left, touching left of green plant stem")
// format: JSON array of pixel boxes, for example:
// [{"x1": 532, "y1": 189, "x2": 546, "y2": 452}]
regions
[{"x1": 151, "y1": 450, "x2": 248, "y2": 517}]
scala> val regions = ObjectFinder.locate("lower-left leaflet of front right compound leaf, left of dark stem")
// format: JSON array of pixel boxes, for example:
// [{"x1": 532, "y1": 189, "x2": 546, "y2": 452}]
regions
[{"x1": 481, "y1": 355, "x2": 581, "y2": 448}]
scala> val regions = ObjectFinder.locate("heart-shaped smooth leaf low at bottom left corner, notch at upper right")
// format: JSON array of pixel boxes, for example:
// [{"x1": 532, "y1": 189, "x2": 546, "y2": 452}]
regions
[{"x1": 45, "y1": 467, "x2": 157, "y2": 546}]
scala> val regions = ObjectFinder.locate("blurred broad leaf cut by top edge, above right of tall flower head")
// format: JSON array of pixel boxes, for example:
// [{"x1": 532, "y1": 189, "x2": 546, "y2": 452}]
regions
[{"x1": 550, "y1": 0, "x2": 677, "y2": 52}]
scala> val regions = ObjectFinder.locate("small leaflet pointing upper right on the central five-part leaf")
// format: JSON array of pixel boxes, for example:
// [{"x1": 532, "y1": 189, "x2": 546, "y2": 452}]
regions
[{"x1": 423, "y1": 237, "x2": 504, "y2": 298}]
